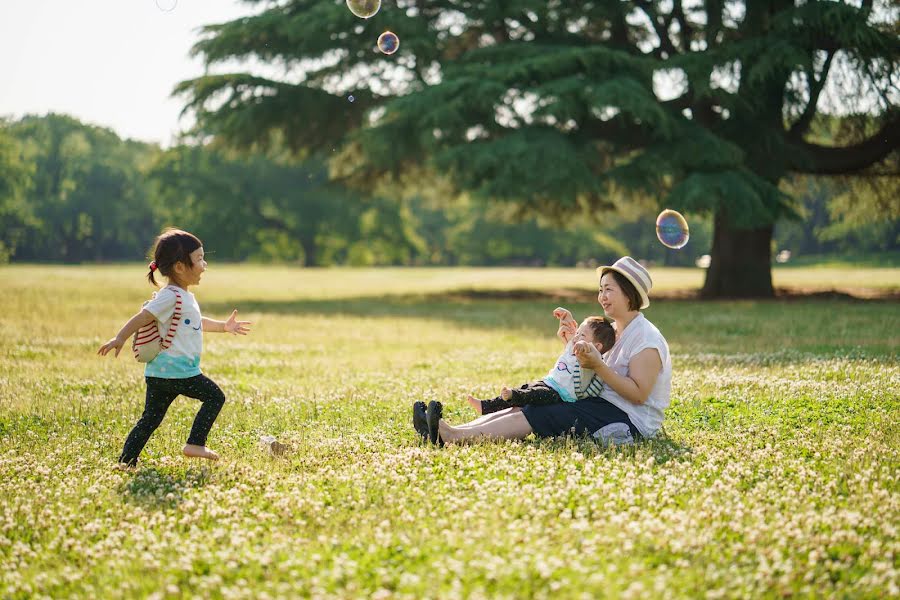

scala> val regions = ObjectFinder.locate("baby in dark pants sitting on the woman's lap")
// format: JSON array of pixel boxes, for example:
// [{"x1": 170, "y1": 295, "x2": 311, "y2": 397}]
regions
[{"x1": 467, "y1": 308, "x2": 616, "y2": 415}]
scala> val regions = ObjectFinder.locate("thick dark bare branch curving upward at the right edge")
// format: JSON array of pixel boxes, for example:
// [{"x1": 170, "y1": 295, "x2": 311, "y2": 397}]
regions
[{"x1": 791, "y1": 116, "x2": 900, "y2": 175}]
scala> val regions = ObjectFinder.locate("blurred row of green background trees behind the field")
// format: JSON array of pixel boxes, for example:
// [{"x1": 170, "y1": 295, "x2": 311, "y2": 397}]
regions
[{"x1": 0, "y1": 114, "x2": 900, "y2": 266}]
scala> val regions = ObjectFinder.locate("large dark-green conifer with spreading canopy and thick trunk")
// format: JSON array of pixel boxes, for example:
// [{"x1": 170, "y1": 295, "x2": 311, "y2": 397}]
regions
[{"x1": 176, "y1": 0, "x2": 900, "y2": 296}]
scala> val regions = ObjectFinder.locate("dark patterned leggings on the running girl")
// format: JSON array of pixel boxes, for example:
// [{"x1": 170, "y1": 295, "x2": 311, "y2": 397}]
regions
[{"x1": 119, "y1": 375, "x2": 225, "y2": 465}]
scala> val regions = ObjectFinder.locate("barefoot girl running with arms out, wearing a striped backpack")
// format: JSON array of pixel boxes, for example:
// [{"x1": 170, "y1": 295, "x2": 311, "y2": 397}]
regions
[{"x1": 97, "y1": 229, "x2": 250, "y2": 466}]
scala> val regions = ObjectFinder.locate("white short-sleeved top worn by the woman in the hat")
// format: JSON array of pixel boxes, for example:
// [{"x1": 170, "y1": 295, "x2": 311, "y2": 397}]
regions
[{"x1": 602, "y1": 313, "x2": 672, "y2": 437}]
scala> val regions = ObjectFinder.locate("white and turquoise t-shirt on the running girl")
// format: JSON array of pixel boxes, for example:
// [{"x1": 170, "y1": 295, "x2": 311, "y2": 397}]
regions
[{"x1": 144, "y1": 285, "x2": 203, "y2": 379}]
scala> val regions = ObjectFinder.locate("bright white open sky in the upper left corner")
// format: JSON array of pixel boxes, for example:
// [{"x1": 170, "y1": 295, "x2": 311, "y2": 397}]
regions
[{"x1": 0, "y1": 0, "x2": 253, "y2": 146}]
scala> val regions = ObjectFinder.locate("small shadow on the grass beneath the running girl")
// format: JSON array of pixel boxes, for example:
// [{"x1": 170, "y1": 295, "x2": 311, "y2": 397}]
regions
[{"x1": 119, "y1": 467, "x2": 211, "y2": 510}]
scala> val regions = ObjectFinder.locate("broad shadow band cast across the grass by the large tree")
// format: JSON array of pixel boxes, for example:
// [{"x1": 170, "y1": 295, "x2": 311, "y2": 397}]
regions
[{"x1": 204, "y1": 289, "x2": 898, "y2": 362}]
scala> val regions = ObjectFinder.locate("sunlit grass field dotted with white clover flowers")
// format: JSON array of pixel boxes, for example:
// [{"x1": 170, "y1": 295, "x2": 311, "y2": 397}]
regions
[{"x1": 0, "y1": 263, "x2": 900, "y2": 598}]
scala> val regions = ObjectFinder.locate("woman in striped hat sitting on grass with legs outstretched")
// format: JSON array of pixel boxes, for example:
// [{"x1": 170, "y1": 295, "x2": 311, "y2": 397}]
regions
[{"x1": 413, "y1": 256, "x2": 672, "y2": 445}]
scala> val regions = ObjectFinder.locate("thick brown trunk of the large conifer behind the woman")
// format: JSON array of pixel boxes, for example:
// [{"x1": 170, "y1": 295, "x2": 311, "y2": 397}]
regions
[{"x1": 700, "y1": 213, "x2": 775, "y2": 298}]
